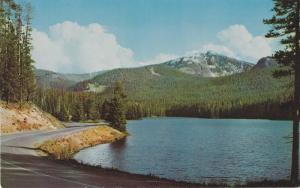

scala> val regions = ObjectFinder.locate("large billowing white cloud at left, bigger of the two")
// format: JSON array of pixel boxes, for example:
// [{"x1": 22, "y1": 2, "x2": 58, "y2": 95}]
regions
[{"x1": 32, "y1": 21, "x2": 135, "y2": 73}]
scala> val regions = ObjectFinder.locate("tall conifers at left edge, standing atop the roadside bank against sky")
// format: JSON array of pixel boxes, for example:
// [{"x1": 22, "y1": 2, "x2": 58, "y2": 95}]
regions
[{"x1": 0, "y1": 0, "x2": 35, "y2": 104}]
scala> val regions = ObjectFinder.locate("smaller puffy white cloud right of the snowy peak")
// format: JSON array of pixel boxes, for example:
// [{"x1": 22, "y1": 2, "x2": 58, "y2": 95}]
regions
[{"x1": 201, "y1": 25, "x2": 272, "y2": 62}]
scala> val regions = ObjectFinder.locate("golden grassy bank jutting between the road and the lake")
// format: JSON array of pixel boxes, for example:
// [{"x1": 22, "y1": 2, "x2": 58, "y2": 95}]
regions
[{"x1": 39, "y1": 126, "x2": 126, "y2": 160}]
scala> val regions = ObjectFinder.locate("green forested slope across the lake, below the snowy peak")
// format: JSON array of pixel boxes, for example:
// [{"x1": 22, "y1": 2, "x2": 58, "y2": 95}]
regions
[{"x1": 101, "y1": 67, "x2": 293, "y2": 119}]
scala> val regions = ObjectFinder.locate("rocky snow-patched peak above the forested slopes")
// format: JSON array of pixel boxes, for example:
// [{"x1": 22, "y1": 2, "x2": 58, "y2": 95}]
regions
[{"x1": 165, "y1": 52, "x2": 253, "y2": 77}]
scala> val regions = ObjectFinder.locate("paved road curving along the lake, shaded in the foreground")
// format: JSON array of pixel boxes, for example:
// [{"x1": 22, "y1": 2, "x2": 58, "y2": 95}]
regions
[{"x1": 1, "y1": 124, "x2": 199, "y2": 188}]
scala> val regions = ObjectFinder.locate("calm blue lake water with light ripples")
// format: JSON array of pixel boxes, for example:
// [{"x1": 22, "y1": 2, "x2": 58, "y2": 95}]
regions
[{"x1": 74, "y1": 118, "x2": 292, "y2": 183}]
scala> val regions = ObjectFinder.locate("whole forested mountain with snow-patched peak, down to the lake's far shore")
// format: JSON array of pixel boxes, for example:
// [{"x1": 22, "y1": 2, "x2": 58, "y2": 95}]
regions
[{"x1": 36, "y1": 53, "x2": 292, "y2": 119}]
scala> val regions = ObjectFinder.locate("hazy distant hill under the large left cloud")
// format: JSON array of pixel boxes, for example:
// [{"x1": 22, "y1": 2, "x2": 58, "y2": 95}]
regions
[{"x1": 35, "y1": 69, "x2": 105, "y2": 88}]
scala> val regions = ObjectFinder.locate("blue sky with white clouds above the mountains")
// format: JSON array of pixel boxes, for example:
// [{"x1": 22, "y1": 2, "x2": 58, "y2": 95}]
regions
[{"x1": 20, "y1": 0, "x2": 276, "y2": 73}]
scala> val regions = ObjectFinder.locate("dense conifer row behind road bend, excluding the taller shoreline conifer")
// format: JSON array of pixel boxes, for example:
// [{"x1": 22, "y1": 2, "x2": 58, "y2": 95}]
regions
[{"x1": 34, "y1": 88, "x2": 103, "y2": 121}]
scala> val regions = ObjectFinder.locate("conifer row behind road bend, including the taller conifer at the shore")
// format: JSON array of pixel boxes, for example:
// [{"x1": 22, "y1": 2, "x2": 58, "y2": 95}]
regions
[{"x1": 34, "y1": 83, "x2": 126, "y2": 131}]
